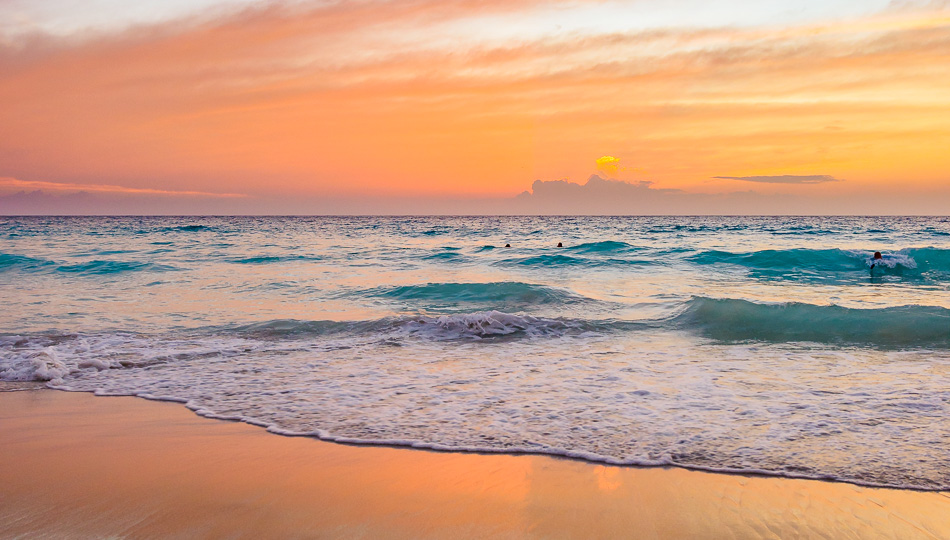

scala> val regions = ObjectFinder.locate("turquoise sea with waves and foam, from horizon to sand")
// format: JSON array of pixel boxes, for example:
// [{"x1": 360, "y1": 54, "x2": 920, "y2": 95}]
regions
[{"x1": 0, "y1": 216, "x2": 950, "y2": 490}]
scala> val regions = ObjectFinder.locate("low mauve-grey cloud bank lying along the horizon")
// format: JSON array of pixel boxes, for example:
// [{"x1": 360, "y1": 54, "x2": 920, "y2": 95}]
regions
[{"x1": 0, "y1": 175, "x2": 948, "y2": 215}]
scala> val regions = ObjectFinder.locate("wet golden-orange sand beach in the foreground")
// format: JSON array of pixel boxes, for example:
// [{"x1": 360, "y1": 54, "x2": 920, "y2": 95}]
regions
[{"x1": 0, "y1": 385, "x2": 950, "y2": 538}]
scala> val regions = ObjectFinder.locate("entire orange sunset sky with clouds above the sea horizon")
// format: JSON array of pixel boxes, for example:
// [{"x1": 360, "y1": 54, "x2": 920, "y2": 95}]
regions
[{"x1": 0, "y1": 0, "x2": 950, "y2": 215}]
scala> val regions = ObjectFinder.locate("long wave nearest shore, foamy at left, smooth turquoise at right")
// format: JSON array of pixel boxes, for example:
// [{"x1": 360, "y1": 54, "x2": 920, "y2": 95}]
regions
[{"x1": 0, "y1": 296, "x2": 950, "y2": 381}]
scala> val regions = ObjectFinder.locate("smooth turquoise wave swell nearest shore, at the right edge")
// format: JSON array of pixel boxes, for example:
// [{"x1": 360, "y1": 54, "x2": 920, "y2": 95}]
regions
[{"x1": 670, "y1": 297, "x2": 950, "y2": 348}]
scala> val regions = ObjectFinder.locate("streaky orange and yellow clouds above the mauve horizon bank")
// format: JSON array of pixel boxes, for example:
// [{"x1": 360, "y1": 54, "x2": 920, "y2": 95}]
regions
[{"x1": 0, "y1": 0, "x2": 950, "y2": 213}]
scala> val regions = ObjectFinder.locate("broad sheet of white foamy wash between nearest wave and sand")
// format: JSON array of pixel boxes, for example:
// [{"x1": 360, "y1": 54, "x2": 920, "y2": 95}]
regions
[{"x1": 0, "y1": 326, "x2": 950, "y2": 489}]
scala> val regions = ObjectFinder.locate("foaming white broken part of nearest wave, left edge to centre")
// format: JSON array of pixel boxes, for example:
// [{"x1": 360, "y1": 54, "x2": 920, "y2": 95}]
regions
[{"x1": 0, "y1": 311, "x2": 610, "y2": 382}]
